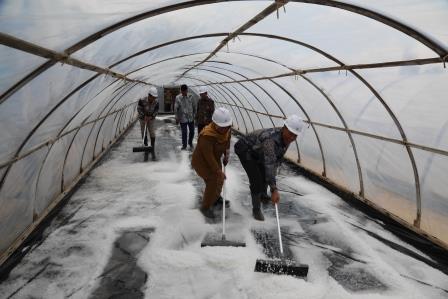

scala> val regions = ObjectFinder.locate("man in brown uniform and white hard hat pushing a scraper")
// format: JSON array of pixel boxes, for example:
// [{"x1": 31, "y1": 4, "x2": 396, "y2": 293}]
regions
[{"x1": 191, "y1": 108, "x2": 232, "y2": 218}]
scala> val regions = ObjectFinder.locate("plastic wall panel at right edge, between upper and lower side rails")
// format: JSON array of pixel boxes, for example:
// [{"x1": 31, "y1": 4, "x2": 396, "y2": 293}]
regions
[{"x1": 360, "y1": 64, "x2": 448, "y2": 150}]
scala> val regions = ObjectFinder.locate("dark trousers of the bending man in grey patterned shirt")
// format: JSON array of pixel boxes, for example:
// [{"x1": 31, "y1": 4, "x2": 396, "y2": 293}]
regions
[{"x1": 238, "y1": 155, "x2": 268, "y2": 209}]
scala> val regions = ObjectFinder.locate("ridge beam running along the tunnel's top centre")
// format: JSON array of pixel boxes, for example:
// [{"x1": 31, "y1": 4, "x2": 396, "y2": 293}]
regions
[{"x1": 178, "y1": 0, "x2": 289, "y2": 80}]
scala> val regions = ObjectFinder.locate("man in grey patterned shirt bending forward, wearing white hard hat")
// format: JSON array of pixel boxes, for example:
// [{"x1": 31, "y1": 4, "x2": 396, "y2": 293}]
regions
[{"x1": 234, "y1": 115, "x2": 304, "y2": 221}]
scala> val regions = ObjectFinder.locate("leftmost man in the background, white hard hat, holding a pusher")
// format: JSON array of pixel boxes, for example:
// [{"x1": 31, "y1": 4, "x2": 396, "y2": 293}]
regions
[{"x1": 137, "y1": 86, "x2": 159, "y2": 160}]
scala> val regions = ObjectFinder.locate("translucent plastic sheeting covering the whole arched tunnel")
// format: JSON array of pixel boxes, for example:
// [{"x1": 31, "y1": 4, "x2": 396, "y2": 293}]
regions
[{"x1": 0, "y1": 0, "x2": 448, "y2": 254}]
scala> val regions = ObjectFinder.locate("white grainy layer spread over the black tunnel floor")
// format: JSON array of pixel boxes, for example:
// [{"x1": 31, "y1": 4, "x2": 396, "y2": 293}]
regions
[{"x1": 0, "y1": 118, "x2": 448, "y2": 299}]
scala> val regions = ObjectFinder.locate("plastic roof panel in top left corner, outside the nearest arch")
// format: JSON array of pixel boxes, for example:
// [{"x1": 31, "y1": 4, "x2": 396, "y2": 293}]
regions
[{"x1": 0, "y1": 0, "x2": 192, "y2": 51}]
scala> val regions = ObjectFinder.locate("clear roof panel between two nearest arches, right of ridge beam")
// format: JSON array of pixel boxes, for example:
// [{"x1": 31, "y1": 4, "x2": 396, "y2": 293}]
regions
[{"x1": 247, "y1": 2, "x2": 436, "y2": 64}]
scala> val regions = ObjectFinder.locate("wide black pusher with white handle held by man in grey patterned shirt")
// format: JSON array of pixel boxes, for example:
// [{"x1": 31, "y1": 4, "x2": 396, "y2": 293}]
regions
[{"x1": 255, "y1": 204, "x2": 308, "y2": 278}]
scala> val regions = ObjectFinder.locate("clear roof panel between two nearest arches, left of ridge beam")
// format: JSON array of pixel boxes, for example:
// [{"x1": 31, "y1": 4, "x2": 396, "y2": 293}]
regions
[{"x1": 74, "y1": 1, "x2": 266, "y2": 66}]
